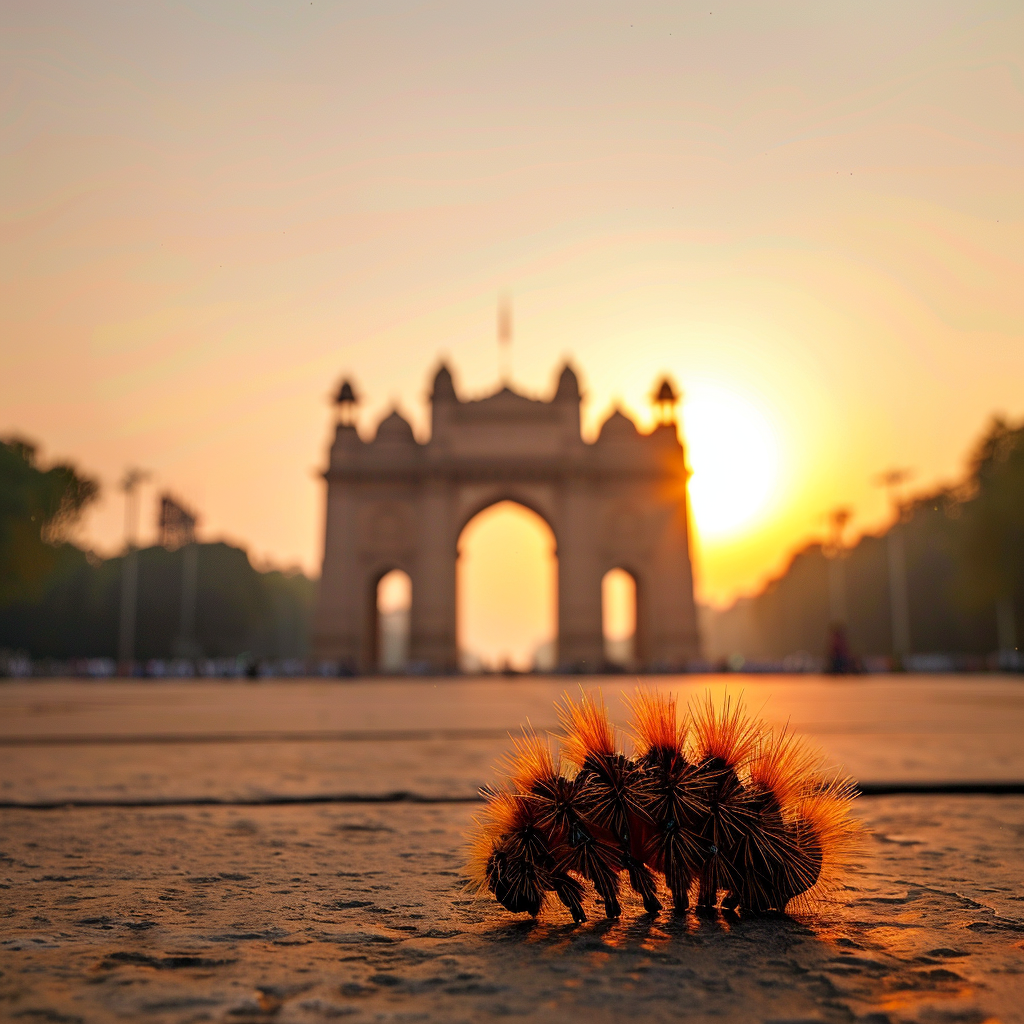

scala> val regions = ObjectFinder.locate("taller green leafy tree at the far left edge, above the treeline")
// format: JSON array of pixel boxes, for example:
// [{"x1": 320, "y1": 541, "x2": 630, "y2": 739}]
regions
[{"x1": 0, "y1": 438, "x2": 99, "y2": 607}]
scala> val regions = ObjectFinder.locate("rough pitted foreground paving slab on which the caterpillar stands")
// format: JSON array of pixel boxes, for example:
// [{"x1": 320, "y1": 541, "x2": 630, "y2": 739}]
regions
[{"x1": 0, "y1": 797, "x2": 1024, "y2": 1024}]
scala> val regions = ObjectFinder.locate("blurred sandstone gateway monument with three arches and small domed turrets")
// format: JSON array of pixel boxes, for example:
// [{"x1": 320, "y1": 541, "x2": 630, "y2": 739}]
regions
[{"x1": 313, "y1": 366, "x2": 698, "y2": 673}]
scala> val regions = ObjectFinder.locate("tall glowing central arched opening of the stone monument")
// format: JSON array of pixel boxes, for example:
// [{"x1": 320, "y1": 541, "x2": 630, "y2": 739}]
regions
[{"x1": 456, "y1": 501, "x2": 558, "y2": 672}]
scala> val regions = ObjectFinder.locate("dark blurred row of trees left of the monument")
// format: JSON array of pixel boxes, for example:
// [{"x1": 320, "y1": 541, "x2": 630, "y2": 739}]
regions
[{"x1": 0, "y1": 439, "x2": 315, "y2": 660}]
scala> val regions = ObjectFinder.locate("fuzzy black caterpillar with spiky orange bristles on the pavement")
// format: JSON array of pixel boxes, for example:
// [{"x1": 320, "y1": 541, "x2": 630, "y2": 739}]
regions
[{"x1": 466, "y1": 690, "x2": 860, "y2": 924}]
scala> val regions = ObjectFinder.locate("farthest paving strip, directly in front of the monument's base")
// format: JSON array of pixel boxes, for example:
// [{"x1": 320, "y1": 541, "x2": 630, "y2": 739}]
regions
[{"x1": 0, "y1": 674, "x2": 1024, "y2": 738}]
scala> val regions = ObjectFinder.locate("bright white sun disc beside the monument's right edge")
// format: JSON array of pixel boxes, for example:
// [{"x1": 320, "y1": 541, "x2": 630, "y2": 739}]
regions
[{"x1": 682, "y1": 383, "x2": 780, "y2": 541}]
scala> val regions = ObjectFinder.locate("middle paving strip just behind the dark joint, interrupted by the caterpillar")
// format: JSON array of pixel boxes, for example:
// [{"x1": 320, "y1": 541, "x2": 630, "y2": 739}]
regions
[{"x1": 0, "y1": 733, "x2": 1024, "y2": 804}]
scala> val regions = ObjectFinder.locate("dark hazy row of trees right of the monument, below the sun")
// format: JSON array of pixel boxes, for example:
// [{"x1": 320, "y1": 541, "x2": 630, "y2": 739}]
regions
[{"x1": 706, "y1": 418, "x2": 1024, "y2": 659}]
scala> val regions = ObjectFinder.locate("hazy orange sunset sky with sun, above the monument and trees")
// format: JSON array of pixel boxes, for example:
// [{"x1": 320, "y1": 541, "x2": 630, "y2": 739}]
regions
[{"x1": 0, "y1": 0, "x2": 1024, "y2": 655}]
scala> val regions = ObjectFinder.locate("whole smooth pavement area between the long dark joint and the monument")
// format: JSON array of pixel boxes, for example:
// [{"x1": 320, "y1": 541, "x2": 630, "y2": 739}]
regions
[{"x1": 0, "y1": 677, "x2": 1024, "y2": 803}]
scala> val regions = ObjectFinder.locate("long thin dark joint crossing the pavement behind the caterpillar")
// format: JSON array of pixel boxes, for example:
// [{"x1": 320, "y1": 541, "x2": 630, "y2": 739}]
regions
[{"x1": 0, "y1": 782, "x2": 1024, "y2": 811}]
